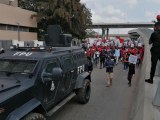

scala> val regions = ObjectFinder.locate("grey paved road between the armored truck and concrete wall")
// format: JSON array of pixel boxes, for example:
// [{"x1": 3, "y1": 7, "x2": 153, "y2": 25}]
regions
[{"x1": 48, "y1": 64, "x2": 138, "y2": 120}]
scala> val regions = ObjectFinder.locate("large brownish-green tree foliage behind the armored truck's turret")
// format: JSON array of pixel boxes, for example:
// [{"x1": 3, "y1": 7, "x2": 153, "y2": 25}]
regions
[{"x1": 19, "y1": 0, "x2": 92, "y2": 38}]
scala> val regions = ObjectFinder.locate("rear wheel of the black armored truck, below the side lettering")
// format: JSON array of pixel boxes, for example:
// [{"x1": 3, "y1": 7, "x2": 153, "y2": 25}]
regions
[{"x1": 76, "y1": 79, "x2": 91, "y2": 104}]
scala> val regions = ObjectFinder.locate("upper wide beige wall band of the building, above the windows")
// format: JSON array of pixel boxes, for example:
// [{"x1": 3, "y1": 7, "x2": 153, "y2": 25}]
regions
[{"x1": 0, "y1": 4, "x2": 37, "y2": 28}]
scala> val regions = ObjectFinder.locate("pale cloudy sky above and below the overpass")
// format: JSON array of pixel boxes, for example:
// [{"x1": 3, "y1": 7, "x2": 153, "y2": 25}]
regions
[{"x1": 81, "y1": 0, "x2": 160, "y2": 34}]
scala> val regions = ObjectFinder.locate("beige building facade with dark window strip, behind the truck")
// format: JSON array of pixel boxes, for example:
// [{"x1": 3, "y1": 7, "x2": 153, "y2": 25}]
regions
[{"x1": 0, "y1": 0, "x2": 37, "y2": 41}]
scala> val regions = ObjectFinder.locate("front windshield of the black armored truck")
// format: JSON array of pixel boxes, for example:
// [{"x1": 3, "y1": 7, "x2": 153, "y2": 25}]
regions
[{"x1": 0, "y1": 60, "x2": 37, "y2": 73}]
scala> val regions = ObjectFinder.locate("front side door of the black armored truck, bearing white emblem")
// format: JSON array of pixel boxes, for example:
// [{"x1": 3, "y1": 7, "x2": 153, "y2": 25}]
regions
[{"x1": 42, "y1": 58, "x2": 61, "y2": 107}]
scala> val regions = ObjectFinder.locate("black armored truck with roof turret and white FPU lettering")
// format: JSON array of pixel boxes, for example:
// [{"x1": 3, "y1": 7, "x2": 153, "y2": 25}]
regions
[{"x1": 0, "y1": 25, "x2": 91, "y2": 120}]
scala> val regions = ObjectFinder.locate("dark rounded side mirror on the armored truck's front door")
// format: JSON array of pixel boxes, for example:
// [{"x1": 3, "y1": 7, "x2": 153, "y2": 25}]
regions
[{"x1": 52, "y1": 67, "x2": 63, "y2": 80}]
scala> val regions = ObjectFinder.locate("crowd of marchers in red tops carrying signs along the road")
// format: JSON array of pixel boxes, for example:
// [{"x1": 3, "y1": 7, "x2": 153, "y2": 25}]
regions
[{"x1": 85, "y1": 39, "x2": 144, "y2": 87}]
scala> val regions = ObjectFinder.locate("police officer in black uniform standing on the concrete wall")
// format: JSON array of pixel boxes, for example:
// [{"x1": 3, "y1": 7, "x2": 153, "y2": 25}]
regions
[{"x1": 145, "y1": 15, "x2": 160, "y2": 84}]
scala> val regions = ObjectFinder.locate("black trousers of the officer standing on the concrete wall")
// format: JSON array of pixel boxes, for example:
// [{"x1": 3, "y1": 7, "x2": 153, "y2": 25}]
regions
[{"x1": 150, "y1": 48, "x2": 160, "y2": 80}]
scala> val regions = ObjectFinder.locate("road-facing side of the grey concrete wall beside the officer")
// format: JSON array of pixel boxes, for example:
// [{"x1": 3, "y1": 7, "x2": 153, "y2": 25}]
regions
[{"x1": 130, "y1": 29, "x2": 152, "y2": 120}]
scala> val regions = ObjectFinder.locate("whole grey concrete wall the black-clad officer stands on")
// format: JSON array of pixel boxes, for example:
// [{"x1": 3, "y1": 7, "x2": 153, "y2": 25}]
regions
[{"x1": 130, "y1": 29, "x2": 160, "y2": 120}]
